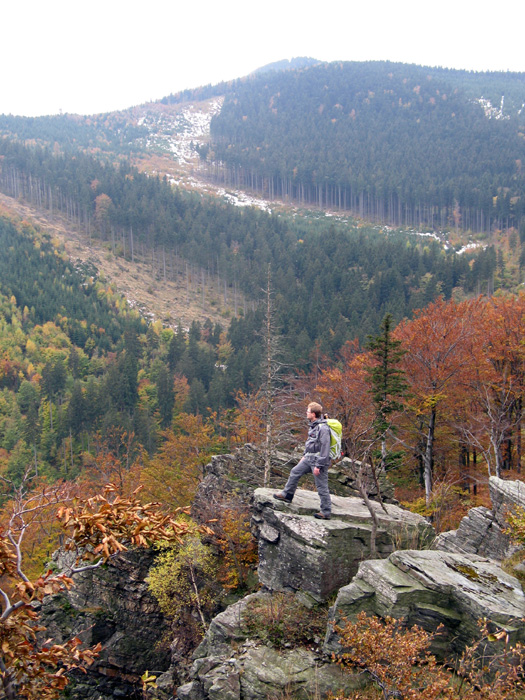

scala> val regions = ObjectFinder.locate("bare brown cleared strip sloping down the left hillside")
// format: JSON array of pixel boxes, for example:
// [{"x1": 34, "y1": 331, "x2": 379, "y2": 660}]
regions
[{"x1": 0, "y1": 193, "x2": 235, "y2": 328}]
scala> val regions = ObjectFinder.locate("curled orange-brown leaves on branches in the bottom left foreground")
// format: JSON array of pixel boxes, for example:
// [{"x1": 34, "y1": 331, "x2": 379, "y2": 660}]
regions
[{"x1": 0, "y1": 472, "x2": 202, "y2": 700}]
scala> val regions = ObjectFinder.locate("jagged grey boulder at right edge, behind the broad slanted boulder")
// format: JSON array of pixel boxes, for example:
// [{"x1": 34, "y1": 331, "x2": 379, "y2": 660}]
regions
[{"x1": 433, "y1": 476, "x2": 525, "y2": 561}]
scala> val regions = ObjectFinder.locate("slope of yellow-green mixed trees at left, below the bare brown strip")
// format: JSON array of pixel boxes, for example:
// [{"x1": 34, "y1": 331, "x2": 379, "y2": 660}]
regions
[{"x1": 0, "y1": 211, "x2": 250, "y2": 483}]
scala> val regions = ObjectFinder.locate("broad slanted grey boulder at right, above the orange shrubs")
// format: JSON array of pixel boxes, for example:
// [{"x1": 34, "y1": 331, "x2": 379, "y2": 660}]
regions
[{"x1": 325, "y1": 550, "x2": 525, "y2": 659}]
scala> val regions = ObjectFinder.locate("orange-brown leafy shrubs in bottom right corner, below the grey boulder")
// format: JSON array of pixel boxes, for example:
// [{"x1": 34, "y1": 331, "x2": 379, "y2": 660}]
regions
[{"x1": 336, "y1": 612, "x2": 525, "y2": 700}]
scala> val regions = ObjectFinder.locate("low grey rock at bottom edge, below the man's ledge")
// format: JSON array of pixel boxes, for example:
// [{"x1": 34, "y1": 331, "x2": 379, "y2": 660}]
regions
[{"x1": 177, "y1": 593, "x2": 363, "y2": 700}]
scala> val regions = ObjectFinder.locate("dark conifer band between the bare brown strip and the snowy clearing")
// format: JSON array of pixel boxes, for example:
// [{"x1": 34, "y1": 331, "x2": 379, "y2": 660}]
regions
[{"x1": 0, "y1": 140, "x2": 497, "y2": 364}]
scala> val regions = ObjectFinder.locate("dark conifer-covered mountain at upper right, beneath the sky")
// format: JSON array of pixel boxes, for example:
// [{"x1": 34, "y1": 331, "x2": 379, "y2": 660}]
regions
[{"x1": 207, "y1": 62, "x2": 525, "y2": 231}]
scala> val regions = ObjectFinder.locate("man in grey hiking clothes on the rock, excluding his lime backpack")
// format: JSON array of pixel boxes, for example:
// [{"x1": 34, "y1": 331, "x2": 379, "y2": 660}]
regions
[{"x1": 273, "y1": 403, "x2": 332, "y2": 520}]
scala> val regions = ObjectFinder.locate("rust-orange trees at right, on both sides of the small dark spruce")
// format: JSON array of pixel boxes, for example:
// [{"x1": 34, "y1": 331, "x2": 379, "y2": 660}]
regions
[{"x1": 312, "y1": 293, "x2": 525, "y2": 525}]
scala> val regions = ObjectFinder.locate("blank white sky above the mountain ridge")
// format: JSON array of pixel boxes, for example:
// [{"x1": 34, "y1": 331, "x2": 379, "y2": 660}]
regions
[{"x1": 0, "y1": 0, "x2": 525, "y2": 116}]
